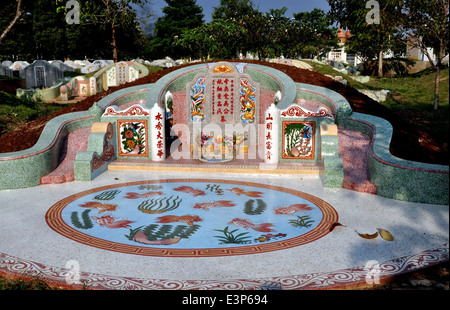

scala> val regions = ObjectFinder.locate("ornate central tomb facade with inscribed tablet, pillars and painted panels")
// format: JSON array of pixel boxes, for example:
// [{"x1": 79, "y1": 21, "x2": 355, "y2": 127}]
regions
[{"x1": 81, "y1": 62, "x2": 344, "y2": 186}]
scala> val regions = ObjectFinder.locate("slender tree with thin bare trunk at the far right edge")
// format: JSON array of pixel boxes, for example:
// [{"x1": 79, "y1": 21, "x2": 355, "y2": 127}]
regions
[{"x1": 399, "y1": 0, "x2": 449, "y2": 111}]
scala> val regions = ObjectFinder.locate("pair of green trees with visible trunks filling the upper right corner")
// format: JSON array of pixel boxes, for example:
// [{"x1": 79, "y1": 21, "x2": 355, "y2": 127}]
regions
[{"x1": 328, "y1": 0, "x2": 449, "y2": 110}]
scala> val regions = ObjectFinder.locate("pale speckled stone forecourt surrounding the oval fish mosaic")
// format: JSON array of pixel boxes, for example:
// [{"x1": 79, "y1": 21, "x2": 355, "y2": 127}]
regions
[{"x1": 0, "y1": 171, "x2": 449, "y2": 289}]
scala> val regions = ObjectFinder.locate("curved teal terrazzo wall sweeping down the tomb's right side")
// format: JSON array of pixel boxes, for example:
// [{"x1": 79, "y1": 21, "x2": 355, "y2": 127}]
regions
[{"x1": 339, "y1": 113, "x2": 449, "y2": 205}]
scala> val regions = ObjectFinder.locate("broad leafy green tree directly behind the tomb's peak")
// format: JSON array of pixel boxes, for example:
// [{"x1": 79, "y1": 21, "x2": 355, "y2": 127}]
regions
[{"x1": 176, "y1": 0, "x2": 337, "y2": 59}]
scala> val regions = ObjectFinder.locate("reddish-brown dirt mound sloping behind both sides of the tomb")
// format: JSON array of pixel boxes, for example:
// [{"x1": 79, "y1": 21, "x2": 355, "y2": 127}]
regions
[{"x1": 0, "y1": 61, "x2": 449, "y2": 165}]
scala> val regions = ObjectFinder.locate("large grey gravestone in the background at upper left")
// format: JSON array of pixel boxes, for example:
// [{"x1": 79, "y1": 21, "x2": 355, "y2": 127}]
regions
[{"x1": 20, "y1": 60, "x2": 64, "y2": 89}]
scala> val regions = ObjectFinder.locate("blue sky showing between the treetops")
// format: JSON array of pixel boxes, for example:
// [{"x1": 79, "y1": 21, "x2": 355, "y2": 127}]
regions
[{"x1": 150, "y1": 0, "x2": 330, "y2": 22}]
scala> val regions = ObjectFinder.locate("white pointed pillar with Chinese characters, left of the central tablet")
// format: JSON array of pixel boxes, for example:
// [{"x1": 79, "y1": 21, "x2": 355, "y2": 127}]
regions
[{"x1": 149, "y1": 103, "x2": 166, "y2": 161}]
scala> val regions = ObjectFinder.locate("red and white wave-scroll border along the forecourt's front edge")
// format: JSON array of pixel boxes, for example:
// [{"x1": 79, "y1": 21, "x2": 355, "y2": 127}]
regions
[{"x1": 0, "y1": 243, "x2": 449, "y2": 290}]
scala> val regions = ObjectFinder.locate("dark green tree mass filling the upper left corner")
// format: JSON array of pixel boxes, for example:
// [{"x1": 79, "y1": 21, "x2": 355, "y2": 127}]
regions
[{"x1": 0, "y1": 0, "x2": 147, "y2": 62}]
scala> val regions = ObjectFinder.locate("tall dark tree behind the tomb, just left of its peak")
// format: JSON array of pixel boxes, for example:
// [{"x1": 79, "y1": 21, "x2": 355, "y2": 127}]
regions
[{"x1": 152, "y1": 0, "x2": 204, "y2": 58}]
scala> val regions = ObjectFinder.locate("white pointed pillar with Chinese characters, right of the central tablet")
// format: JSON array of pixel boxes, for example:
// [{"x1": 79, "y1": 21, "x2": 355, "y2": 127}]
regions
[{"x1": 264, "y1": 104, "x2": 280, "y2": 164}]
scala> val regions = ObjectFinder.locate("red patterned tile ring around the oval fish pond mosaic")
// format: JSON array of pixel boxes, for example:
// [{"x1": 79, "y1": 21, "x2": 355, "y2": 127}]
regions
[{"x1": 45, "y1": 179, "x2": 338, "y2": 257}]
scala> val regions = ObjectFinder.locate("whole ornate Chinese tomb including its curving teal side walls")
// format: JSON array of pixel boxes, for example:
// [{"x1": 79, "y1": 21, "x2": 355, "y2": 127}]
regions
[{"x1": 0, "y1": 62, "x2": 448, "y2": 204}]
